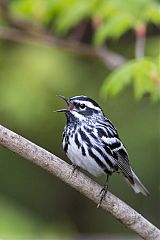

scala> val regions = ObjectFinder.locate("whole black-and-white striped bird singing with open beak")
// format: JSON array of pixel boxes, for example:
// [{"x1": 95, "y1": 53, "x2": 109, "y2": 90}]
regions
[{"x1": 56, "y1": 95, "x2": 150, "y2": 207}]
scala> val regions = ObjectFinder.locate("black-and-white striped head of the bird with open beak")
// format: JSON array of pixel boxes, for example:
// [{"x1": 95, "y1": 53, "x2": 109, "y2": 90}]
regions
[{"x1": 56, "y1": 96, "x2": 104, "y2": 121}]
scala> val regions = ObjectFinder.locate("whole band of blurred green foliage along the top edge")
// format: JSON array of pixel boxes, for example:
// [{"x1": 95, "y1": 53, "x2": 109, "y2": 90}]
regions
[{"x1": 11, "y1": 0, "x2": 160, "y2": 37}]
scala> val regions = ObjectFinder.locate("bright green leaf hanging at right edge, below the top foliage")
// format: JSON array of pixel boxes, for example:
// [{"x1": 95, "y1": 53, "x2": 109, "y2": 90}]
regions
[{"x1": 101, "y1": 58, "x2": 160, "y2": 101}]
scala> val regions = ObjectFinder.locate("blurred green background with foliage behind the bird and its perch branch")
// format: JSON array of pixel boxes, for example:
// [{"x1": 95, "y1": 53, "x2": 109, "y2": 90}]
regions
[{"x1": 0, "y1": 0, "x2": 160, "y2": 239}]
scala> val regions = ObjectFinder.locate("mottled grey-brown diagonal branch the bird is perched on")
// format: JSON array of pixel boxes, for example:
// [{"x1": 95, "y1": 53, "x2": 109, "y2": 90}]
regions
[{"x1": 0, "y1": 125, "x2": 160, "y2": 240}]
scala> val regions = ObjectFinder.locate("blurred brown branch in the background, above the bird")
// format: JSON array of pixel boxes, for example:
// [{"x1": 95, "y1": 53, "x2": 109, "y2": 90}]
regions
[{"x1": 0, "y1": 27, "x2": 127, "y2": 69}]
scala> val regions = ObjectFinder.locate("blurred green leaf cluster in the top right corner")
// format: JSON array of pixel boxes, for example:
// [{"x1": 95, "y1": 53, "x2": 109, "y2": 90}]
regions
[{"x1": 94, "y1": 0, "x2": 160, "y2": 45}]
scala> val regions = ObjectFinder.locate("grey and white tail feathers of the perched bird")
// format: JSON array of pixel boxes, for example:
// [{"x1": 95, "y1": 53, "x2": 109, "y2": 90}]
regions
[{"x1": 125, "y1": 169, "x2": 150, "y2": 196}]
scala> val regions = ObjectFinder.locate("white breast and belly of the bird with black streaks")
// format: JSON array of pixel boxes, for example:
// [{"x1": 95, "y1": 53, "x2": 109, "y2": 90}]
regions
[{"x1": 63, "y1": 119, "x2": 119, "y2": 176}]
